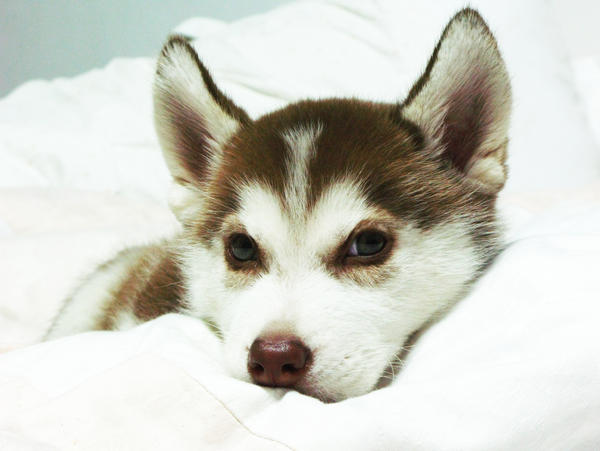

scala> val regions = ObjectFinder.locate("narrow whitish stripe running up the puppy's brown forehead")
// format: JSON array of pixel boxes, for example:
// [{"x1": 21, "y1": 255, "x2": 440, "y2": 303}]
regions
[{"x1": 282, "y1": 123, "x2": 323, "y2": 220}]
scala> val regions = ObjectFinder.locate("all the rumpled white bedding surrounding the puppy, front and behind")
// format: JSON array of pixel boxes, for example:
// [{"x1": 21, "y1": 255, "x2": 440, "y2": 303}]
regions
[{"x1": 0, "y1": 0, "x2": 600, "y2": 450}]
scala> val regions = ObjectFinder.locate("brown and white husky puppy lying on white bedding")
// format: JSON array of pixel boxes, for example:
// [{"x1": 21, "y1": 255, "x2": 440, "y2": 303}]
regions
[{"x1": 47, "y1": 9, "x2": 511, "y2": 401}]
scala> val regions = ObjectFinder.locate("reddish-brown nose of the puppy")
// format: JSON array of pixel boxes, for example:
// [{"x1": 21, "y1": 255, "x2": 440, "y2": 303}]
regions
[{"x1": 248, "y1": 336, "x2": 311, "y2": 387}]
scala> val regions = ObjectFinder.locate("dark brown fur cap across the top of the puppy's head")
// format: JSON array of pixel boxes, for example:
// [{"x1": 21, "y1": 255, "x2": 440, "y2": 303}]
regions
[{"x1": 195, "y1": 99, "x2": 495, "y2": 262}]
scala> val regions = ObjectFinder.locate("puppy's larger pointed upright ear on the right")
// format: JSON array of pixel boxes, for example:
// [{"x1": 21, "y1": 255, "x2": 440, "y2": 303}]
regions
[{"x1": 401, "y1": 8, "x2": 511, "y2": 193}]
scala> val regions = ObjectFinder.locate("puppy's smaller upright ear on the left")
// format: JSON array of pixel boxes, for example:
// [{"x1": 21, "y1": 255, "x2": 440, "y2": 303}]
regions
[{"x1": 153, "y1": 36, "x2": 251, "y2": 213}]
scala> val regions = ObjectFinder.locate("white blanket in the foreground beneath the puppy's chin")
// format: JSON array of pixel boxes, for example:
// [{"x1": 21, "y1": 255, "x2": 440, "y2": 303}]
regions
[{"x1": 0, "y1": 185, "x2": 600, "y2": 450}]
